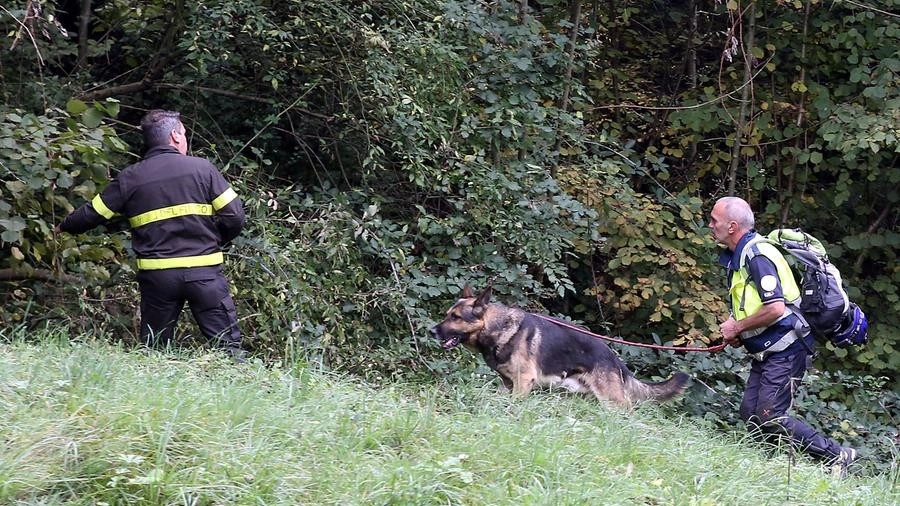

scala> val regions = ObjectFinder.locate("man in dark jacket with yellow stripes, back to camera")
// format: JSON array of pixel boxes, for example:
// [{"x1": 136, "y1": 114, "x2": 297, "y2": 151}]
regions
[{"x1": 57, "y1": 110, "x2": 245, "y2": 359}]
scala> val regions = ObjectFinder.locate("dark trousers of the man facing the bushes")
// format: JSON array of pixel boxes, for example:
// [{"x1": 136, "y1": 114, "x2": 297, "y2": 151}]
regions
[{"x1": 137, "y1": 265, "x2": 241, "y2": 350}]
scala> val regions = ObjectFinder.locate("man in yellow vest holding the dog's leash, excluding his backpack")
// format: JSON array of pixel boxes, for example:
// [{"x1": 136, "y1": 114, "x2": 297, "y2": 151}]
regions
[{"x1": 709, "y1": 197, "x2": 857, "y2": 474}]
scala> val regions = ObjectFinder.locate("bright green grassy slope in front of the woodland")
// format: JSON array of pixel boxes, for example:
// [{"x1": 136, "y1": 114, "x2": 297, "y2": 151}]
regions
[{"x1": 0, "y1": 336, "x2": 900, "y2": 506}]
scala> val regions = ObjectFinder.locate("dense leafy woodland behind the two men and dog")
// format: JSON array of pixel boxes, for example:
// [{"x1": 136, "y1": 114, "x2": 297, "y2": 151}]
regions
[{"x1": 0, "y1": 0, "x2": 900, "y2": 465}]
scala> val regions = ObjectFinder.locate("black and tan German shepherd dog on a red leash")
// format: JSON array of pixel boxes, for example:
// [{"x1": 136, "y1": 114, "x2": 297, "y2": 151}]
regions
[{"x1": 431, "y1": 285, "x2": 689, "y2": 408}]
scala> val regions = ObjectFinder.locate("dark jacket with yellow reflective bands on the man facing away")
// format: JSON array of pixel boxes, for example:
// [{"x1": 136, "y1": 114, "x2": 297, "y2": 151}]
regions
[{"x1": 60, "y1": 146, "x2": 246, "y2": 270}]
